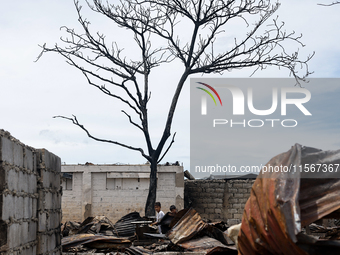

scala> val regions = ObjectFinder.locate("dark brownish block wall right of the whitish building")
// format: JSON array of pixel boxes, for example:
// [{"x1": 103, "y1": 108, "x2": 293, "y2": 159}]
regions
[{"x1": 184, "y1": 179, "x2": 254, "y2": 226}]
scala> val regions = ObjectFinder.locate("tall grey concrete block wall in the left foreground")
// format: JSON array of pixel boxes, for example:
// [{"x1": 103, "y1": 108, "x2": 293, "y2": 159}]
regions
[{"x1": 0, "y1": 130, "x2": 61, "y2": 255}]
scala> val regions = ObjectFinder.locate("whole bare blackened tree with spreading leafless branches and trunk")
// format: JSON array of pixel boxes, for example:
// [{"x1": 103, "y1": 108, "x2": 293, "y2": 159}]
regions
[{"x1": 38, "y1": 0, "x2": 312, "y2": 215}]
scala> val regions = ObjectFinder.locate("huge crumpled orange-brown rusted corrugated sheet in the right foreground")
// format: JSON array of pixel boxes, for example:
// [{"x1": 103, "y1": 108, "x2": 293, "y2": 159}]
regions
[{"x1": 238, "y1": 144, "x2": 340, "y2": 255}]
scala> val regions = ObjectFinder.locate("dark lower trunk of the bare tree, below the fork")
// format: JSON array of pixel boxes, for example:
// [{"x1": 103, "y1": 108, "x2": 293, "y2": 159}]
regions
[{"x1": 145, "y1": 161, "x2": 157, "y2": 216}]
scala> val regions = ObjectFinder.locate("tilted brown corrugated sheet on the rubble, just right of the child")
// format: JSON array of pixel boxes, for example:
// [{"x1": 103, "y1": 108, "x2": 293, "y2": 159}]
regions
[{"x1": 166, "y1": 208, "x2": 206, "y2": 244}]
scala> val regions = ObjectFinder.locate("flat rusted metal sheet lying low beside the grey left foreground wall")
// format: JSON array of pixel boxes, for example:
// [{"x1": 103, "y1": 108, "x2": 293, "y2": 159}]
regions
[{"x1": 62, "y1": 234, "x2": 131, "y2": 250}]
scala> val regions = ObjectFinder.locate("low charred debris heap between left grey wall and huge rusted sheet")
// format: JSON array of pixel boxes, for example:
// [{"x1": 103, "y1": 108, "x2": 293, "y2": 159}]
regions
[{"x1": 62, "y1": 208, "x2": 237, "y2": 255}]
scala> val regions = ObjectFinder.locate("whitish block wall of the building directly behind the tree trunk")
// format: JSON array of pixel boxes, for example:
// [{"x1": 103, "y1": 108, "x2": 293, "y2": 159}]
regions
[{"x1": 61, "y1": 165, "x2": 184, "y2": 222}]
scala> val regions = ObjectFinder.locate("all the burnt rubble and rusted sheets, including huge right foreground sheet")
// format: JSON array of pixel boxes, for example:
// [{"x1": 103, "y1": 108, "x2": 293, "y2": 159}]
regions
[{"x1": 62, "y1": 144, "x2": 340, "y2": 255}]
